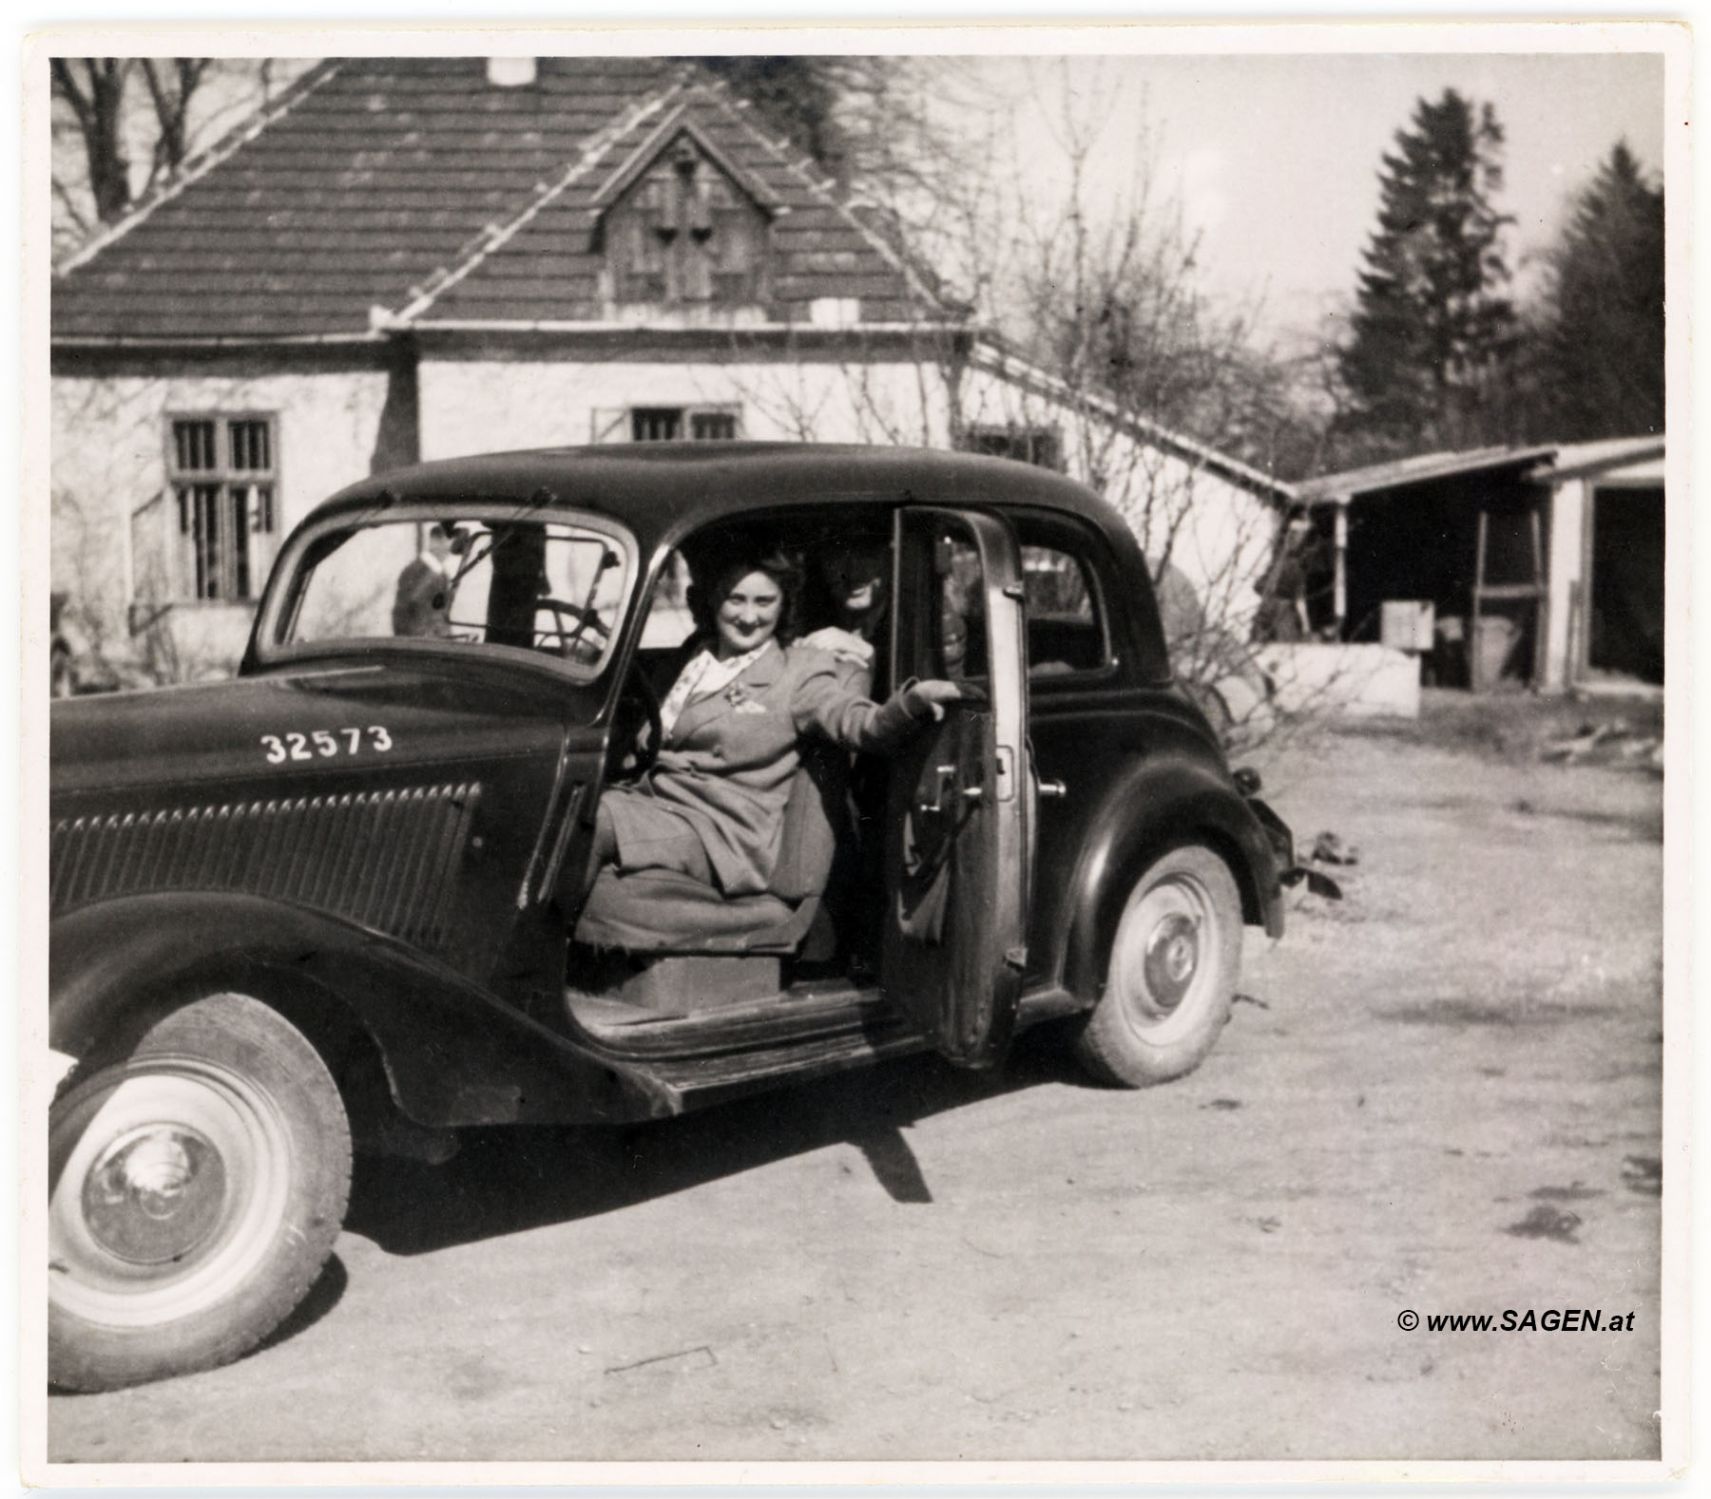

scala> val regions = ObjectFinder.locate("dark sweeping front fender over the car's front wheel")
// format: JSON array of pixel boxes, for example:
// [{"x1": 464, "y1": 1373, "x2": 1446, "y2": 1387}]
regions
[{"x1": 48, "y1": 892, "x2": 674, "y2": 1128}]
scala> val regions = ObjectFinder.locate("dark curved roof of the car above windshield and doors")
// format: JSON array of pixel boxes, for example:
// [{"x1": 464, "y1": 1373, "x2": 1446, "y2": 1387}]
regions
[{"x1": 311, "y1": 441, "x2": 1128, "y2": 546}]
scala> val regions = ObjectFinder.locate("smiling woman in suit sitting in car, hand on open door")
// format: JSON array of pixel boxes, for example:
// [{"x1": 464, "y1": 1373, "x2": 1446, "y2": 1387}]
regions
[{"x1": 592, "y1": 551, "x2": 962, "y2": 895}]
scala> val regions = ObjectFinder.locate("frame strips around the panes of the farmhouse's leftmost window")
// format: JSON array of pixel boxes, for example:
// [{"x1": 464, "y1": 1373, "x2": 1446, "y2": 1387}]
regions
[{"x1": 161, "y1": 407, "x2": 284, "y2": 607}]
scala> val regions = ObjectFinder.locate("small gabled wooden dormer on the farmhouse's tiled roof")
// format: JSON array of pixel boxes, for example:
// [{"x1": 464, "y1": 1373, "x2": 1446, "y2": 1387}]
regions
[{"x1": 602, "y1": 130, "x2": 767, "y2": 308}]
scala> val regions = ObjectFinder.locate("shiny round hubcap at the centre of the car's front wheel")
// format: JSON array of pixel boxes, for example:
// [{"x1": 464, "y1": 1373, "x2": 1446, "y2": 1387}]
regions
[{"x1": 82, "y1": 1124, "x2": 226, "y2": 1265}]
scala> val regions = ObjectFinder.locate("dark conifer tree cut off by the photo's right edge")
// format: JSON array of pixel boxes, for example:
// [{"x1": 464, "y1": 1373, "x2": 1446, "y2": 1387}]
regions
[{"x1": 1533, "y1": 142, "x2": 1663, "y2": 441}]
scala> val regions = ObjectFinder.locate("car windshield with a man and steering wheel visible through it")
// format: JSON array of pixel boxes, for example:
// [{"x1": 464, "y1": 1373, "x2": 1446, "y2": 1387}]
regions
[{"x1": 262, "y1": 507, "x2": 635, "y2": 679}]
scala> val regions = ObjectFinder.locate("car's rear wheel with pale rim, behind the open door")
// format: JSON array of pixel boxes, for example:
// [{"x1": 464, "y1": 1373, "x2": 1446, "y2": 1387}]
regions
[{"x1": 1076, "y1": 845, "x2": 1242, "y2": 1088}]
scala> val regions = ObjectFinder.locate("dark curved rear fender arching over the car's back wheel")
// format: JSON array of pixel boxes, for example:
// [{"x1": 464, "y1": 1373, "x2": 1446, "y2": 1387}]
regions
[{"x1": 1064, "y1": 756, "x2": 1283, "y2": 1001}]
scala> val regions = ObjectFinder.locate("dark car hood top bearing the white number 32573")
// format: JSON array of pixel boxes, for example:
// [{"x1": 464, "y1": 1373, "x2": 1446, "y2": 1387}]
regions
[{"x1": 50, "y1": 666, "x2": 599, "y2": 797}]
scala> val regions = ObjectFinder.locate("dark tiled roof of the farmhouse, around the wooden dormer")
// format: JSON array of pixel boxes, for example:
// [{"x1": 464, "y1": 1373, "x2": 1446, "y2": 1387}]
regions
[{"x1": 53, "y1": 56, "x2": 919, "y2": 341}]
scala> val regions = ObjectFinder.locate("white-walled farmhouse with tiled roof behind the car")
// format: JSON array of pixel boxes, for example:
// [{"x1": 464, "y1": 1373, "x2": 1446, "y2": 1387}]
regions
[{"x1": 51, "y1": 58, "x2": 1288, "y2": 671}]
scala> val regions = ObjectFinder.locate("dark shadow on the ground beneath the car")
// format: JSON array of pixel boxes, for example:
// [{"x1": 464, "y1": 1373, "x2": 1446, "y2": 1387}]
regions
[{"x1": 346, "y1": 1028, "x2": 1090, "y2": 1254}]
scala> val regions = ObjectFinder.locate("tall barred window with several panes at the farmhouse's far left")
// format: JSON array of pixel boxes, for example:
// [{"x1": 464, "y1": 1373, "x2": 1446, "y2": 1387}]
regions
[{"x1": 166, "y1": 416, "x2": 279, "y2": 601}]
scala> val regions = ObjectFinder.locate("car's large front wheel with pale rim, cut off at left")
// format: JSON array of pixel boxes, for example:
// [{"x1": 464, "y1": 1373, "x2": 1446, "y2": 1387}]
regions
[{"x1": 48, "y1": 994, "x2": 351, "y2": 1389}]
